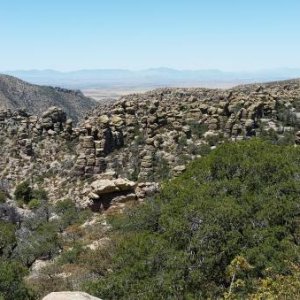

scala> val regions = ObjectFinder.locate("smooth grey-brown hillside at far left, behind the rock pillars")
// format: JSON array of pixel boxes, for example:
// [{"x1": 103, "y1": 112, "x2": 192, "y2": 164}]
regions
[{"x1": 0, "y1": 75, "x2": 96, "y2": 122}]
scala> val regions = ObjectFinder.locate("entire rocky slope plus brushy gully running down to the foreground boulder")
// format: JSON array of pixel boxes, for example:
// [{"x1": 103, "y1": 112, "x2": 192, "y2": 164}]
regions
[{"x1": 0, "y1": 81, "x2": 300, "y2": 296}]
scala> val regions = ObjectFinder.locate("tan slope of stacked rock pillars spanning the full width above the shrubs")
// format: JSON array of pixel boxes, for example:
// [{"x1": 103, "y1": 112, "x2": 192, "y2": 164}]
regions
[{"x1": 0, "y1": 81, "x2": 300, "y2": 210}]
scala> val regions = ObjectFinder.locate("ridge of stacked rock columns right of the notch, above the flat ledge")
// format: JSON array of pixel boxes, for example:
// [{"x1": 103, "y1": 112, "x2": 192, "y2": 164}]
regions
[{"x1": 73, "y1": 81, "x2": 300, "y2": 181}]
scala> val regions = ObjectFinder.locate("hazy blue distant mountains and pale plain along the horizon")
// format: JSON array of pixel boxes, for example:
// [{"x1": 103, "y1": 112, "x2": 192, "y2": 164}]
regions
[{"x1": 4, "y1": 68, "x2": 300, "y2": 89}]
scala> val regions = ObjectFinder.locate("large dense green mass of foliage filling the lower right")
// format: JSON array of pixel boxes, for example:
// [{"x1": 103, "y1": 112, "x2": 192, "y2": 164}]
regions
[{"x1": 86, "y1": 139, "x2": 300, "y2": 299}]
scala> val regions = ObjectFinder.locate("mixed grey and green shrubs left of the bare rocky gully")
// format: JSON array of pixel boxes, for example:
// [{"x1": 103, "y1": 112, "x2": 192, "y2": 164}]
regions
[{"x1": 0, "y1": 191, "x2": 90, "y2": 300}]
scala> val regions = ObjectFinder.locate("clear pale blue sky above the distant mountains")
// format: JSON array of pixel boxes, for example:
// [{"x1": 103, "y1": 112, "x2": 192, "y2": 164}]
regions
[{"x1": 0, "y1": 0, "x2": 300, "y2": 71}]
